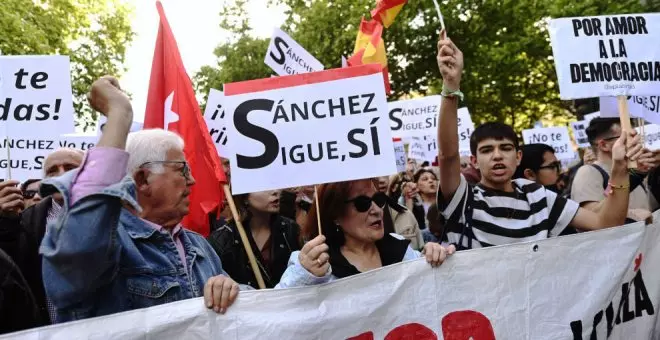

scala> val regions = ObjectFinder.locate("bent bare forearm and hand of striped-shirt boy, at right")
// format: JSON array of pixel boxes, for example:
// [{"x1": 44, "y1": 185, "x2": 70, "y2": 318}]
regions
[{"x1": 571, "y1": 132, "x2": 644, "y2": 230}]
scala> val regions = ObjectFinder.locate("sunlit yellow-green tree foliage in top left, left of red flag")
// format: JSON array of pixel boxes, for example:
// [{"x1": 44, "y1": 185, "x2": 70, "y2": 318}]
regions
[{"x1": 0, "y1": 0, "x2": 133, "y2": 129}]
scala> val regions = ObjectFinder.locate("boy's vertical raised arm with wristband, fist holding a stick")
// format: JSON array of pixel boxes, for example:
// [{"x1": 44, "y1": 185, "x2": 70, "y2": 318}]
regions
[{"x1": 437, "y1": 31, "x2": 463, "y2": 201}]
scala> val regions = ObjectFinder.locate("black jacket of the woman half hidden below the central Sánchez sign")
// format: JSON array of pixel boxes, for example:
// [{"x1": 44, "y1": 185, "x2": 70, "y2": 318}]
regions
[{"x1": 208, "y1": 215, "x2": 300, "y2": 288}]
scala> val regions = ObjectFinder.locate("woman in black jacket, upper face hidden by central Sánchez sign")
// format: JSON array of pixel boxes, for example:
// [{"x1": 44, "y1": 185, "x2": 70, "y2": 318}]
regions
[{"x1": 208, "y1": 190, "x2": 300, "y2": 289}]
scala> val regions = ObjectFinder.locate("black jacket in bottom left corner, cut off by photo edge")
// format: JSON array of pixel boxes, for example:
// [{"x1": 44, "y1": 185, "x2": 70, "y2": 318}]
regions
[{"x1": 0, "y1": 250, "x2": 43, "y2": 334}]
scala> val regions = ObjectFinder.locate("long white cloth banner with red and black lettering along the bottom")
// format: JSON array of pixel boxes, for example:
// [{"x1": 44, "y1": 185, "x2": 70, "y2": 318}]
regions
[{"x1": 9, "y1": 214, "x2": 660, "y2": 340}]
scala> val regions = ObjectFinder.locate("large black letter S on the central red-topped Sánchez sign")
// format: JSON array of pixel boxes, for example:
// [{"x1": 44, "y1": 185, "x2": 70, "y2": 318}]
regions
[{"x1": 234, "y1": 99, "x2": 280, "y2": 169}]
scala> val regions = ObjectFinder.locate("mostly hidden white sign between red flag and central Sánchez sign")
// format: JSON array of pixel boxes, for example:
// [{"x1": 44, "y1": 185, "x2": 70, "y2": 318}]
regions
[{"x1": 204, "y1": 89, "x2": 231, "y2": 158}]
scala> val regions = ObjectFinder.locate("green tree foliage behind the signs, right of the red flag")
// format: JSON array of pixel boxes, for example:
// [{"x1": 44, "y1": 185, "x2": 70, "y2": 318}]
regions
[{"x1": 195, "y1": 0, "x2": 660, "y2": 130}]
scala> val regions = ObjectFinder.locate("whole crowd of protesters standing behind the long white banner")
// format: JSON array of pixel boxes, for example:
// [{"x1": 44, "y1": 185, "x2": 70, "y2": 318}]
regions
[{"x1": 0, "y1": 32, "x2": 660, "y2": 332}]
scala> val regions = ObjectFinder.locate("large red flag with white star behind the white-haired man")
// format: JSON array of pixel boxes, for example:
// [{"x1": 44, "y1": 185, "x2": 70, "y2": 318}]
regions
[{"x1": 144, "y1": 1, "x2": 227, "y2": 237}]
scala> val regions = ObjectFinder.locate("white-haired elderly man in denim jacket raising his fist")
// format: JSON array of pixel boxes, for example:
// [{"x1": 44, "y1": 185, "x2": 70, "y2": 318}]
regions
[{"x1": 41, "y1": 77, "x2": 239, "y2": 322}]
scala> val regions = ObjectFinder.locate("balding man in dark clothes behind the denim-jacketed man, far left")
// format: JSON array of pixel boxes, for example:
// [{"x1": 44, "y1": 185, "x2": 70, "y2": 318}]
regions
[{"x1": 0, "y1": 148, "x2": 84, "y2": 325}]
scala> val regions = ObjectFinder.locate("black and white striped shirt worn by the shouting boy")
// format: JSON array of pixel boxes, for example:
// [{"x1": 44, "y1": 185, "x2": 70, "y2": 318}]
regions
[{"x1": 438, "y1": 175, "x2": 580, "y2": 249}]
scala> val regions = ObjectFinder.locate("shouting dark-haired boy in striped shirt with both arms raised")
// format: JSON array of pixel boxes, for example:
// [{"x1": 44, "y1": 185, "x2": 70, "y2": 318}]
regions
[{"x1": 437, "y1": 35, "x2": 651, "y2": 249}]
